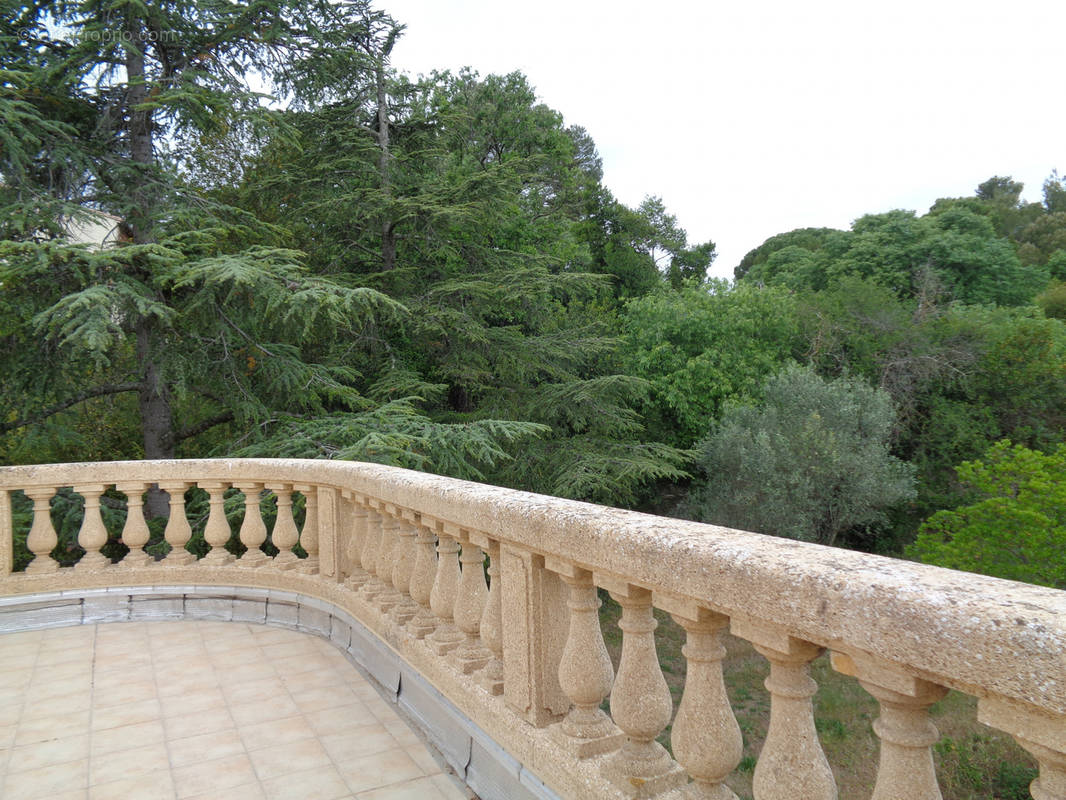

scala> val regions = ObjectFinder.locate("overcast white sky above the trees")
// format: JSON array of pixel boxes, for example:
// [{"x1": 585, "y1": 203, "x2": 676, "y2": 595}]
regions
[{"x1": 377, "y1": 0, "x2": 1066, "y2": 276}]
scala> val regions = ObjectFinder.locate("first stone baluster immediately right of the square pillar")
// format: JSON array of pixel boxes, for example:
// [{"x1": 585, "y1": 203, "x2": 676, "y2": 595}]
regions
[{"x1": 545, "y1": 558, "x2": 626, "y2": 758}]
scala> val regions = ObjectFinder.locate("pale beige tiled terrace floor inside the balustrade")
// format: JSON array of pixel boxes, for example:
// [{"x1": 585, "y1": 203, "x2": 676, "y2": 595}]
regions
[{"x1": 0, "y1": 621, "x2": 470, "y2": 800}]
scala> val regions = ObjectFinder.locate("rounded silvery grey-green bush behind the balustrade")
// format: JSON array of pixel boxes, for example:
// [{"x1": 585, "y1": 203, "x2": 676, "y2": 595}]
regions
[{"x1": 685, "y1": 366, "x2": 915, "y2": 544}]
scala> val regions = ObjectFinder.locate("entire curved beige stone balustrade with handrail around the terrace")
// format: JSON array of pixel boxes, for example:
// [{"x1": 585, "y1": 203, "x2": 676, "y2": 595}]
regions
[{"x1": 0, "y1": 460, "x2": 1066, "y2": 800}]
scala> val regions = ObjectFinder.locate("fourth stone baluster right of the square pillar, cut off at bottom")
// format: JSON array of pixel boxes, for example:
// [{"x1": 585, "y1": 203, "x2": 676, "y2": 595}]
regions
[{"x1": 730, "y1": 619, "x2": 837, "y2": 800}]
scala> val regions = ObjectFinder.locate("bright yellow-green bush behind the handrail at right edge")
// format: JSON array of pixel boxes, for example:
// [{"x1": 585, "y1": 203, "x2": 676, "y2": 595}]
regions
[{"x1": 907, "y1": 439, "x2": 1066, "y2": 589}]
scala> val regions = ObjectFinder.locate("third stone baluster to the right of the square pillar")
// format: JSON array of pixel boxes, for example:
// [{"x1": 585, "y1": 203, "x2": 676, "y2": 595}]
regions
[{"x1": 656, "y1": 595, "x2": 744, "y2": 800}]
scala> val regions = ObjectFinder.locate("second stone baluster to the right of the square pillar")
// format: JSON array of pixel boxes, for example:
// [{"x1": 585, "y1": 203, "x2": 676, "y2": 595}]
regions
[{"x1": 600, "y1": 578, "x2": 687, "y2": 798}]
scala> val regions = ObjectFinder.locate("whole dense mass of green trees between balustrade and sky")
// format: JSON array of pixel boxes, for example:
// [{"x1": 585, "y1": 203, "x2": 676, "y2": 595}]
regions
[{"x1": 6, "y1": 0, "x2": 1066, "y2": 584}]
